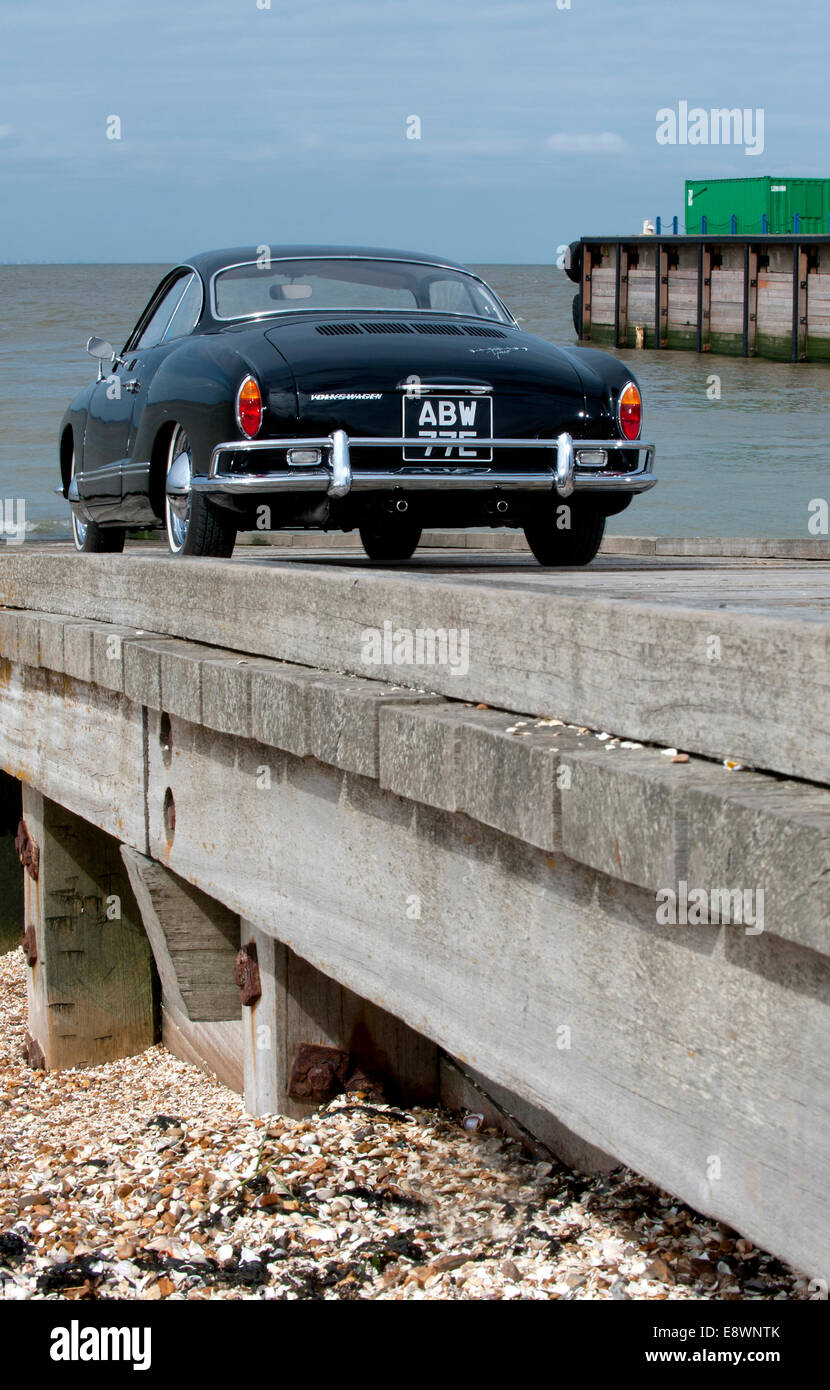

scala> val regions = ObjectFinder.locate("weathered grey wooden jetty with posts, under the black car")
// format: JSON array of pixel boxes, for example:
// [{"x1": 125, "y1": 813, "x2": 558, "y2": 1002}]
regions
[{"x1": 0, "y1": 545, "x2": 830, "y2": 1279}]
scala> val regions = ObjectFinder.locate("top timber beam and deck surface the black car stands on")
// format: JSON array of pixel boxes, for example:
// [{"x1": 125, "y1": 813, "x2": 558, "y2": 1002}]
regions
[{"x1": 0, "y1": 546, "x2": 830, "y2": 783}]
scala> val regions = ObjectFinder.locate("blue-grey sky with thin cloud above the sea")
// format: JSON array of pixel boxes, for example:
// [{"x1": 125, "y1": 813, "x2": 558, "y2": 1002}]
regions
[{"x1": 0, "y1": 0, "x2": 830, "y2": 264}]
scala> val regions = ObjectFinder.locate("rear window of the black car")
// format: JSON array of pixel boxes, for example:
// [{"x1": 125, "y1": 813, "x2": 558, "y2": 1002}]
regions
[{"x1": 213, "y1": 256, "x2": 512, "y2": 324}]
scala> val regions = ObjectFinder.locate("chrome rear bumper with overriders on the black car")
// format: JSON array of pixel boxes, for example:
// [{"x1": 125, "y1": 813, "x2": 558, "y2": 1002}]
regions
[{"x1": 193, "y1": 430, "x2": 658, "y2": 498}]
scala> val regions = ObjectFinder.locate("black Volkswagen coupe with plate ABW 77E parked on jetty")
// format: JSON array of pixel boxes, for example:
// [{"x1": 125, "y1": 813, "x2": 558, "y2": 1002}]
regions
[{"x1": 60, "y1": 246, "x2": 656, "y2": 564}]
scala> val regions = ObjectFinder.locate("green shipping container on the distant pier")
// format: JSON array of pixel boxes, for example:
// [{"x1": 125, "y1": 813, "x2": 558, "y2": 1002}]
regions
[{"x1": 685, "y1": 178, "x2": 830, "y2": 236}]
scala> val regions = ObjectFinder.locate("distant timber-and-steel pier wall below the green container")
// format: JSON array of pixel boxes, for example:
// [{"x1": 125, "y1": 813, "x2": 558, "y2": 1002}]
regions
[{"x1": 567, "y1": 235, "x2": 830, "y2": 361}]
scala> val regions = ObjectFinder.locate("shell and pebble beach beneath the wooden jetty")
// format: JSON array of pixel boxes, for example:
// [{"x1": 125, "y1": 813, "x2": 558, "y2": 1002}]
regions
[{"x1": 0, "y1": 951, "x2": 811, "y2": 1301}]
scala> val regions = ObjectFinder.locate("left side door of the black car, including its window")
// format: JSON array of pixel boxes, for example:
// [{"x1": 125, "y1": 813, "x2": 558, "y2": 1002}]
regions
[{"x1": 78, "y1": 270, "x2": 193, "y2": 521}]
